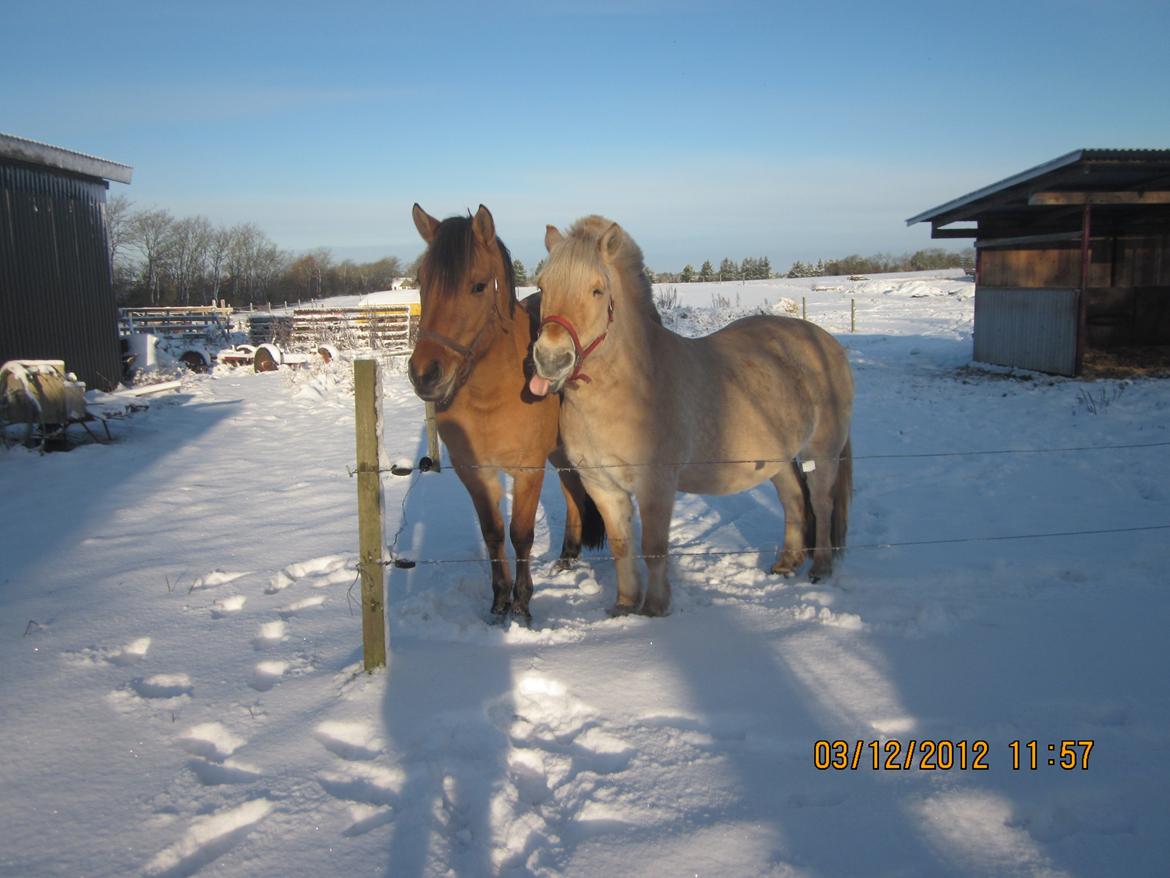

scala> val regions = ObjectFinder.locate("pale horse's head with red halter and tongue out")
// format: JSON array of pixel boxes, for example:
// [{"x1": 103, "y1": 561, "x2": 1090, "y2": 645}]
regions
[{"x1": 529, "y1": 217, "x2": 640, "y2": 396}]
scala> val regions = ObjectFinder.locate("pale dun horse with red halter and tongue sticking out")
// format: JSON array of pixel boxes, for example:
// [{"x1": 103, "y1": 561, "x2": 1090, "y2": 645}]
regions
[{"x1": 529, "y1": 217, "x2": 853, "y2": 615}]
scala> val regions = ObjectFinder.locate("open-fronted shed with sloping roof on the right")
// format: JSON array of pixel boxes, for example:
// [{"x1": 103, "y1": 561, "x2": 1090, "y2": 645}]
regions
[{"x1": 906, "y1": 149, "x2": 1170, "y2": 376}]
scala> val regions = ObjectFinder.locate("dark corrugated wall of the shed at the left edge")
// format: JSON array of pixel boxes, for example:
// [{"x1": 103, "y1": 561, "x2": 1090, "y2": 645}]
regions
[{"x1": 0, "y1": 160, "x2": 122, "y2": 390}]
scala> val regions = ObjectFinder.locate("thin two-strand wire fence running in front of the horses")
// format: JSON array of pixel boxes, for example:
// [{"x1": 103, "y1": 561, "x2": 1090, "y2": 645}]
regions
[{"x1": 350, "y1": 441, "x2": 1170, "y2": 569}]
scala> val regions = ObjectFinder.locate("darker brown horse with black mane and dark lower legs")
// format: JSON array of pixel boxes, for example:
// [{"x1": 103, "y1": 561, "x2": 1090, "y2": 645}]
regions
[{"x1": 410, "y1": 204, "x2": 605, "y2": 623}]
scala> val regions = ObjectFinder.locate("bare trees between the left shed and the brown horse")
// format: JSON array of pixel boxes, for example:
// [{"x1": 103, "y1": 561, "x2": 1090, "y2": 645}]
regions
[{"x1": 105, "y1": 196, "x2": 405, "y2": 308}]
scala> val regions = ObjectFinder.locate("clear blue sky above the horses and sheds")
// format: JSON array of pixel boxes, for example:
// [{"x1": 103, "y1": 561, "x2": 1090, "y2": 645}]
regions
[{"x1": 0, "y1": 0, "x2": 1170, "y2": 270}]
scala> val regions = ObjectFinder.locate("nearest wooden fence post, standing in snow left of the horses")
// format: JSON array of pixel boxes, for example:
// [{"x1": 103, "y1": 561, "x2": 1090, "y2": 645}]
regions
[{"x1": 353, "y1": 359, "x2": 386, "y2": 672}]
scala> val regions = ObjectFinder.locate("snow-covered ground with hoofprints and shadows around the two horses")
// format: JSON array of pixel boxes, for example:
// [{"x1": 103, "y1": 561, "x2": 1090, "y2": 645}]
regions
[{"x1": 0, "y1": 273, "x2": 1170, "y2": 878}]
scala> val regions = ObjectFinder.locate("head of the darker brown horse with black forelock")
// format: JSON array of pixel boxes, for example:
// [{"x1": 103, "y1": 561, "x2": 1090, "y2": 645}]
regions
[{"x1": 410, "y1": 204, "x2": 516, "y2": 403}]
